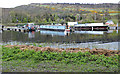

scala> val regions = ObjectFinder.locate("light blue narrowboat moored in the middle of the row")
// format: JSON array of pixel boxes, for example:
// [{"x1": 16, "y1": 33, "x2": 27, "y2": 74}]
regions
[{"x1": 39, "y1": 25, "x2": 71, "y2": 32}]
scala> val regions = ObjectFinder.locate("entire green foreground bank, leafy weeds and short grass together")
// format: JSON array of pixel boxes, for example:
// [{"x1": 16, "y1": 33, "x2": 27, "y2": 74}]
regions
[{"x1": 2, "y1": 46, "x2": 118, "y2": 72}]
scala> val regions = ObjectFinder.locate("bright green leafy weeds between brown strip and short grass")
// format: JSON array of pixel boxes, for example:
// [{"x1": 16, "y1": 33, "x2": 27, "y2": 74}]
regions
[{"x1": 2, "y1": 46, "x2": 118, "y2": 72}]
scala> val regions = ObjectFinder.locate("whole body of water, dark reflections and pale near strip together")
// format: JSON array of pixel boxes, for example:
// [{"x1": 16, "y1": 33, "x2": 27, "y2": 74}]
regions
[{"x1": 0, "y1": 30, "x2": 119, "y2": 50}]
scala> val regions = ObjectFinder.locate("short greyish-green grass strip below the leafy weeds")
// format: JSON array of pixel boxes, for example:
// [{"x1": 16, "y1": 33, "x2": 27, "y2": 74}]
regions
[{"x1": 3, "y1": 60, "x2": 117, "y2": 72}]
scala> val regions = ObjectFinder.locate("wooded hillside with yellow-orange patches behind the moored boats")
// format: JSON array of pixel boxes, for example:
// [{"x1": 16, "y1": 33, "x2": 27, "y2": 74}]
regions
[{"x1": 3, "y1": 3, "x2": 118, "y2": 23}]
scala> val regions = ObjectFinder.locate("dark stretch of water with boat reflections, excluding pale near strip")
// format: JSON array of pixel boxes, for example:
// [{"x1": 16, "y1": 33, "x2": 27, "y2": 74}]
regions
[{"x1": 0, "y1": 30, "x2": 118, "y2": 43}]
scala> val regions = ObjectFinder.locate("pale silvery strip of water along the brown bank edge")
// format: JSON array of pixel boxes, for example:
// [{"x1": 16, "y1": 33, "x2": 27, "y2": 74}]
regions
[{"x1": 0, "y1": 41, "x2": 120, "y2": 50}]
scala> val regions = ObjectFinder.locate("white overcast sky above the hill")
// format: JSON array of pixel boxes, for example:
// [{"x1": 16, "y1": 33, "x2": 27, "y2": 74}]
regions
[{"x1": 0, "y1": 0, "x2": 119, "y2": 8}]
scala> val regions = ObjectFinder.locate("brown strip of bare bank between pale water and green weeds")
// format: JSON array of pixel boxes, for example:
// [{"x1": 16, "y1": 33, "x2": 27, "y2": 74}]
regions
[{"x1": 5, "y1": 45, "x2": 120, "y2": 56}]
